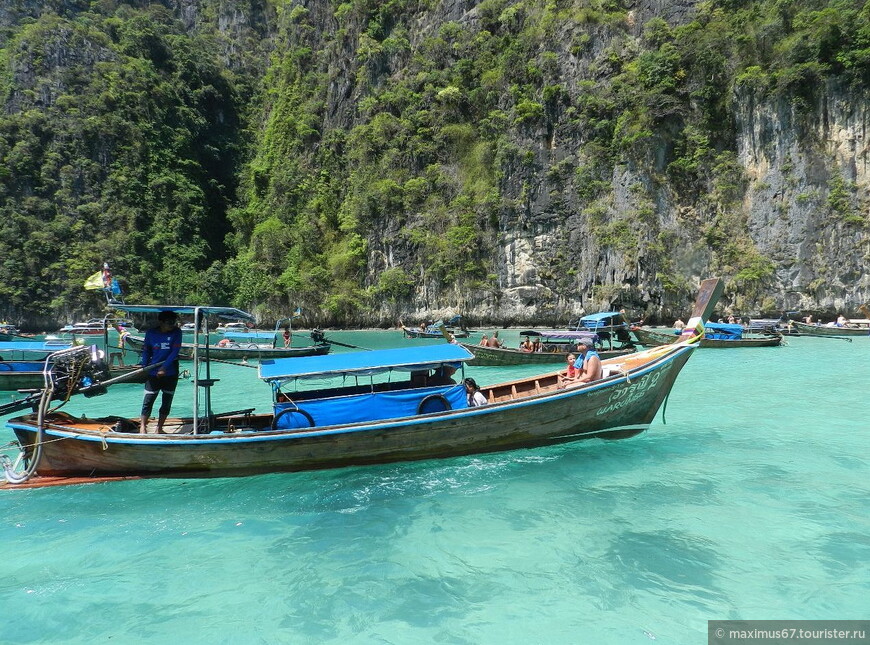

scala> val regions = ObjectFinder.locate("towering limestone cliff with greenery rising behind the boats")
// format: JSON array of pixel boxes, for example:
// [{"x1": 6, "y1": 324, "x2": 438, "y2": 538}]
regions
[{"x1": 0, "y1": 0, "x2": 870, "y2": 324}]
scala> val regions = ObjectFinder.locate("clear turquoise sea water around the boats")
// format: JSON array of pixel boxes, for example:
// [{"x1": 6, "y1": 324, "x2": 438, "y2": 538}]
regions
[{"x1": 0, "y1": 330, "x2": 870, "y2": 644}]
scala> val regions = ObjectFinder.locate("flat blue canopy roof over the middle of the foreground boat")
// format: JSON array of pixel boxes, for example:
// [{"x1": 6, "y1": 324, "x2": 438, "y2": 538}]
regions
[{"x1": 260, "y1": 343, "x2": 474, "y2": 382}]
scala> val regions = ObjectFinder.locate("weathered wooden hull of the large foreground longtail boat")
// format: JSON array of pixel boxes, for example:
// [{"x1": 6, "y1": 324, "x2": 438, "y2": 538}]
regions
[{"x1": 9, "y1": 344, "x2": 695, "y2": 477}]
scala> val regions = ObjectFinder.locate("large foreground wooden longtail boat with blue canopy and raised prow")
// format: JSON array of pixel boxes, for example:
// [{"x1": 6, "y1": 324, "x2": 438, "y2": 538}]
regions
[{"x1": 0, "y1": 280, "x2": 722, "y2": 485}]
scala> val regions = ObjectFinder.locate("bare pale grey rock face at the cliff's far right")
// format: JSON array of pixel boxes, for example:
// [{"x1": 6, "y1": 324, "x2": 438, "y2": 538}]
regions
[{"x1": 735, "y1": 82, "x2": 870, "y2": 311}]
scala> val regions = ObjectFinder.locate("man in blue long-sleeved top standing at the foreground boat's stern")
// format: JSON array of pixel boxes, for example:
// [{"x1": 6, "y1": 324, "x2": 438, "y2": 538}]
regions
[{"x1": 139, "y1": 311, "x2": 181, "y2": 434}]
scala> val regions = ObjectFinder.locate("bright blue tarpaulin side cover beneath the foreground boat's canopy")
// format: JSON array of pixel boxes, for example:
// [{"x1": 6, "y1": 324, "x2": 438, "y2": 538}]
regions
[{"x1": 275, "y1": 382, "x2": 468, "y2": 429}]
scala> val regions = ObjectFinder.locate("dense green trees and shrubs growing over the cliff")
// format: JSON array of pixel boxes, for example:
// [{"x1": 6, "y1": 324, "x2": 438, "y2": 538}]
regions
[{"x1": 0, "y1": 0, "x2": 870, "y2": 323}]
